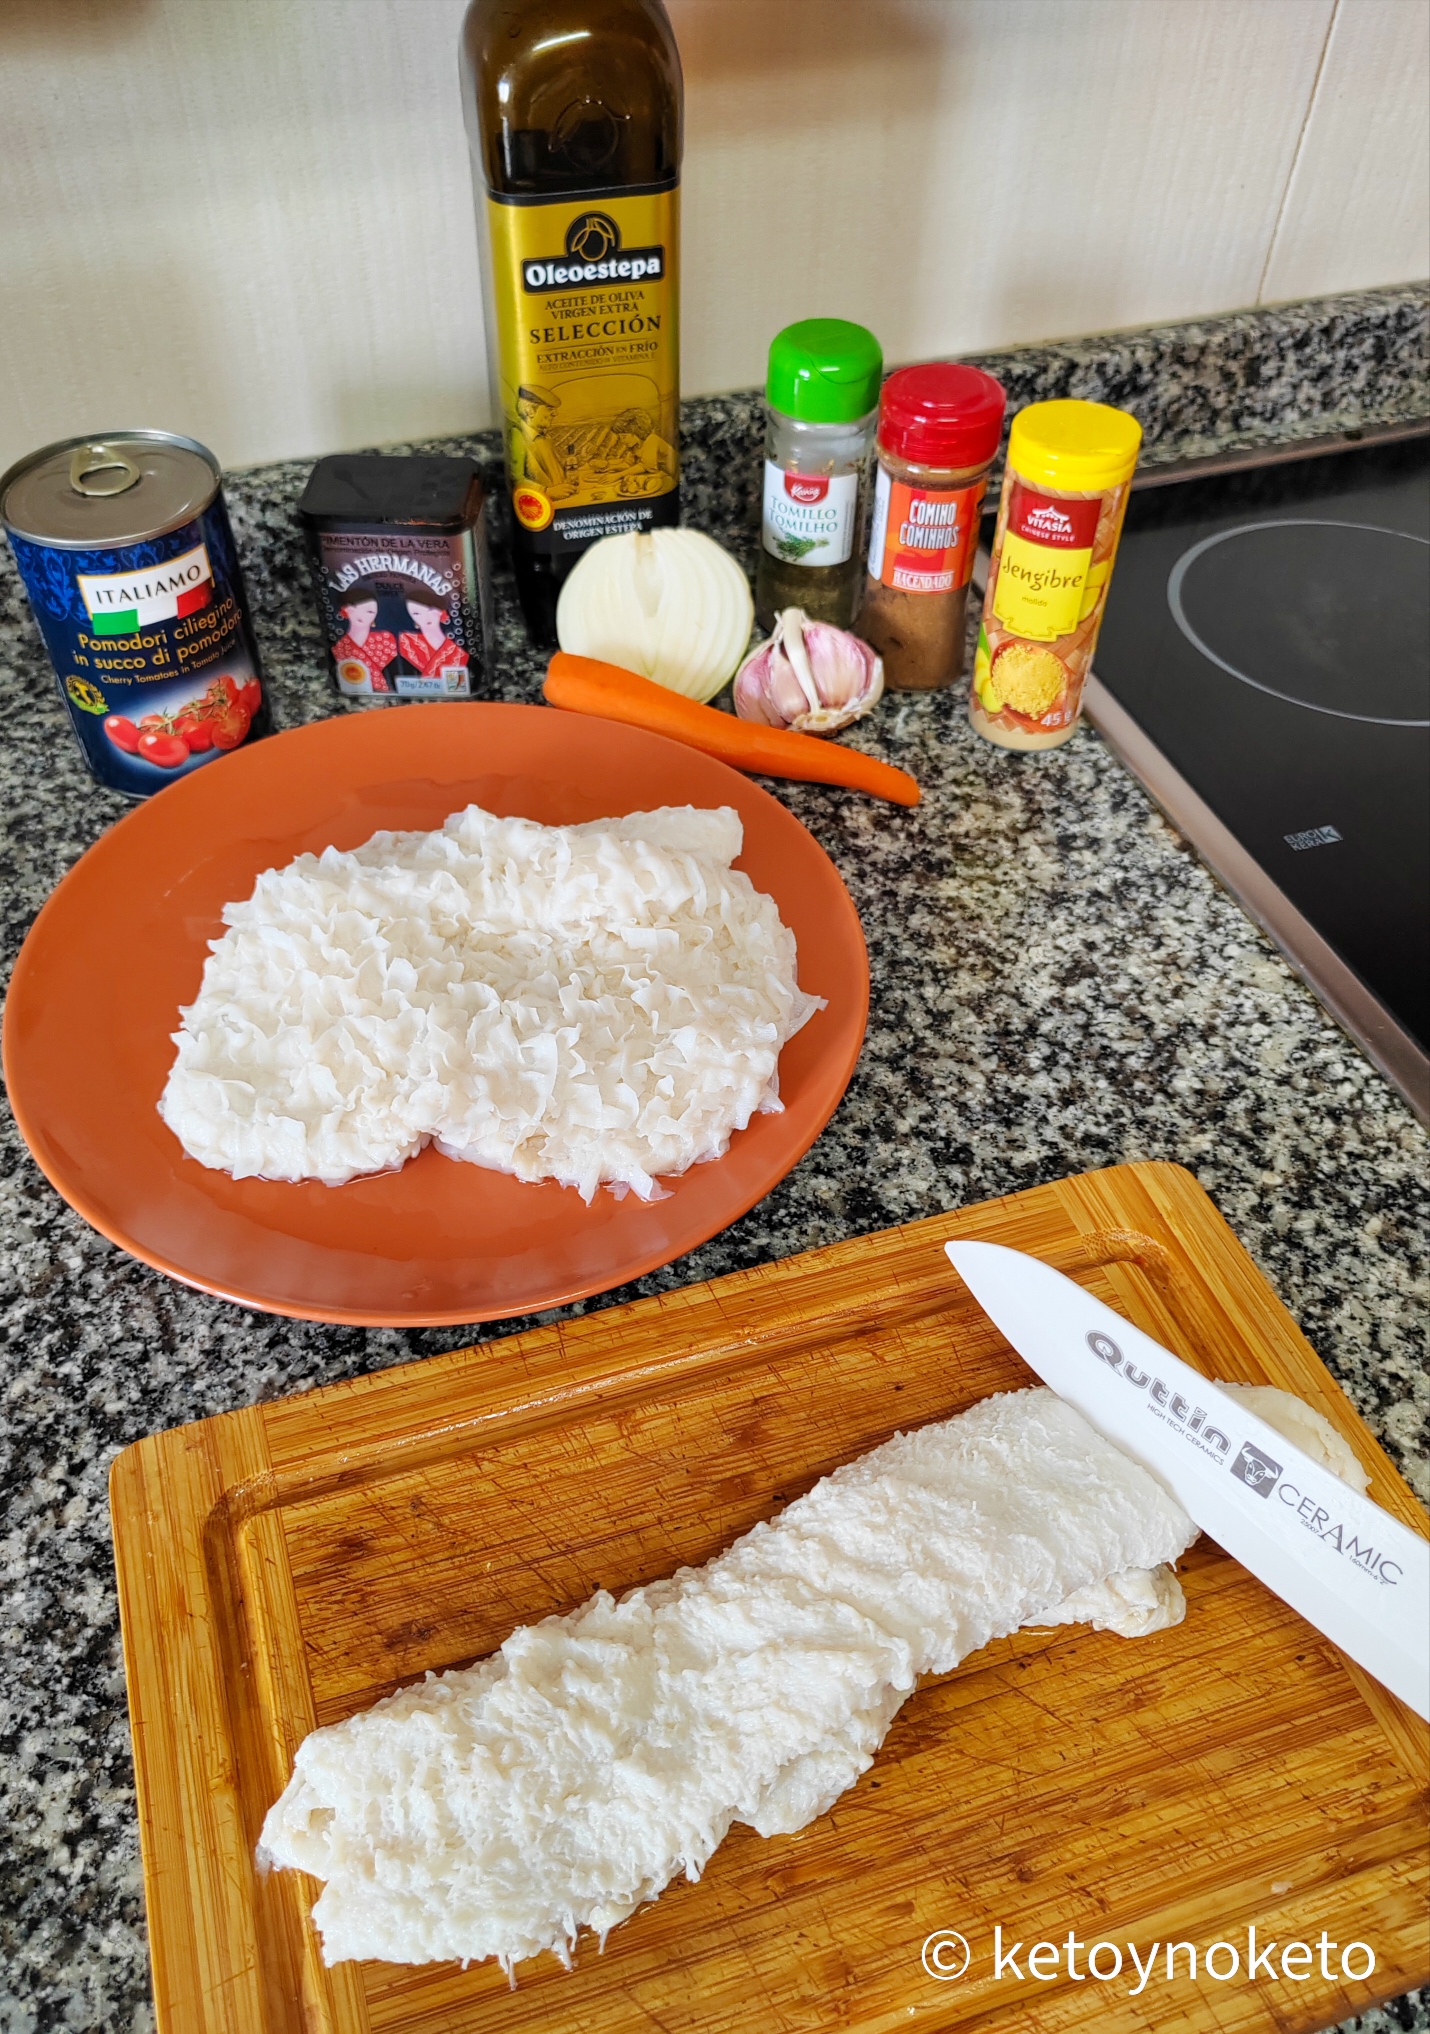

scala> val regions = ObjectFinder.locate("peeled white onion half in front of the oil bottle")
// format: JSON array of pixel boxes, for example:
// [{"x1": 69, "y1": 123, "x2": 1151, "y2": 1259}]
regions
[{"x1": 555, "y1": 529, "x2": 755, "y2": 700}]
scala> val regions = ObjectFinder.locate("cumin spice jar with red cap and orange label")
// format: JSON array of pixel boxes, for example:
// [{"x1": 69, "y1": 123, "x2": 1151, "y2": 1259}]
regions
[{"x1": 856, "y1": 360, "x2": 1007, "y2": 692}]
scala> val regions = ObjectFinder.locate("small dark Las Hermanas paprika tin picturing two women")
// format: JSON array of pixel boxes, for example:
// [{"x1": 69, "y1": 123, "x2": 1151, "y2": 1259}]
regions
[{"x1": 299, "y1": 454, "x2": 492, "y2": 704}]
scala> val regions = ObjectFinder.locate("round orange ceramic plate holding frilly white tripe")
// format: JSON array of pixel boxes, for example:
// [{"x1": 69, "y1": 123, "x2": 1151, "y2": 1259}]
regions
[{"x1": 4, "y1": 704, "x2": 869, "y2": 1326}]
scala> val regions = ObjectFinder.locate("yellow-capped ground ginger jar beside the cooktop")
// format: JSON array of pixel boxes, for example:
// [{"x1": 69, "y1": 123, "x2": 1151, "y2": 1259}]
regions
[{"x1": 968, "y1": 401, "x2": 1141, "y2": 749}]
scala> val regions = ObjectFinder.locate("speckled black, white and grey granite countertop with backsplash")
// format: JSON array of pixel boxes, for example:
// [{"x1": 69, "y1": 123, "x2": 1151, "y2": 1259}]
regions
[{"x1": 0, "y1": 289, "x2": 1430, "y2": 2034}]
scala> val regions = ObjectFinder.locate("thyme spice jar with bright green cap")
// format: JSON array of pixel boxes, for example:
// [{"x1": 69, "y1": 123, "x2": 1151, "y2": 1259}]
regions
[{"x1": 755, "y1": 317, "x2": 883, "y2": 631}]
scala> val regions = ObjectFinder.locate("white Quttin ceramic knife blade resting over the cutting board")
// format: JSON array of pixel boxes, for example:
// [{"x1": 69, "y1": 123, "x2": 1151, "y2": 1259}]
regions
[{"x1": 944, "y1": 1243, "x2": 1430, "y2": 1719}]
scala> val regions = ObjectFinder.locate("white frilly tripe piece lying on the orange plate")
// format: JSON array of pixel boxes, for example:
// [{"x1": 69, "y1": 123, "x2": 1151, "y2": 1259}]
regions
[{"x1": 159, "y1": 805, "x2": 822, "y2": 1200}]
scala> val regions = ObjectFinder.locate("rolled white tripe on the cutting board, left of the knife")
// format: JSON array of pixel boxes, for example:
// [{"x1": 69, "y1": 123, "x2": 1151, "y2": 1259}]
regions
[{"x1": 260, "y1": 1387, "x2": 1196, "y2": 1973}]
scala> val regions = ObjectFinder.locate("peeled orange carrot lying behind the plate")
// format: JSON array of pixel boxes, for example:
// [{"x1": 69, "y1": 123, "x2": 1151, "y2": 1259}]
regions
[{"x1": 541, "y1": 649, "x2": 921, "y2": 805}]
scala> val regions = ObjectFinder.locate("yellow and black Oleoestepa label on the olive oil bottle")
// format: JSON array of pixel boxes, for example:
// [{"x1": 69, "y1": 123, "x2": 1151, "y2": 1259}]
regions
[{"x1": 486, "y1": 189, "x2": 679, "y2": 539}]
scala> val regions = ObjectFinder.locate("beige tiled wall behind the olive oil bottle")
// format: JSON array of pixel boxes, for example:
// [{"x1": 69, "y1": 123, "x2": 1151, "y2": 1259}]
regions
[{"x1": 0, "y1": 0, "x2": 1430, "y2": 464}]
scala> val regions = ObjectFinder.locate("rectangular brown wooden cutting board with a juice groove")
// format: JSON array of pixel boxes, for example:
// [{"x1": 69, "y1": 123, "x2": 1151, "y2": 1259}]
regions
[{"x1": 112, "y1": 1165, "x2": 1430, "y2": 2034}]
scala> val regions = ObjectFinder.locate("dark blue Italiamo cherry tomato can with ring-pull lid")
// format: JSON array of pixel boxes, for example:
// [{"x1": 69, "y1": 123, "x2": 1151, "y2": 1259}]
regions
[{"x1": 0, "y1": 431, "x2": 271, "y2": 797}]
